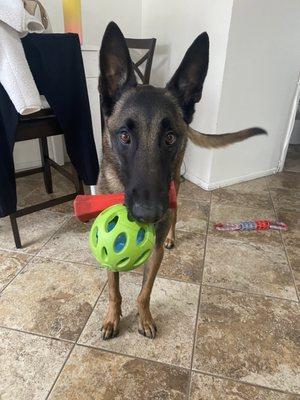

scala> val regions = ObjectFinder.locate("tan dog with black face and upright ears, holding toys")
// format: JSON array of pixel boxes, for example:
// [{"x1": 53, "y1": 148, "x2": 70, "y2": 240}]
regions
[{"x1": 97, "y1": 22, "x2": 265, "y2": 339}]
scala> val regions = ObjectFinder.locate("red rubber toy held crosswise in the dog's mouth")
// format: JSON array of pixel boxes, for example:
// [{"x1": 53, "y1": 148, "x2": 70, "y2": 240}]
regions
[{"x1": 74, "y1": 181, "x2": 177, "y2": 222}]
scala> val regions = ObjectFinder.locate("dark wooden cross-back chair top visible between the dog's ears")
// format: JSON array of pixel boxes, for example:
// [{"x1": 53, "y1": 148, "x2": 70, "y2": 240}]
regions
[{"x1": 125, "y1": 38, "x2": 156, "y2": 85}]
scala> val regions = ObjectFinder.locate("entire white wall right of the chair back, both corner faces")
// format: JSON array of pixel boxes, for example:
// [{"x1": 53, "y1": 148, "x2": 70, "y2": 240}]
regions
[{"x1": 142, "y1": 0, "x2": 300, "y2": 188}]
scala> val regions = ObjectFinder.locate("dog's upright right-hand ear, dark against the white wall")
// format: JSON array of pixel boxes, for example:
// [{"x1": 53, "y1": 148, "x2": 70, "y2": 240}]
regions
[{"x1": 167, "y1": 32, "x2": 209, "y2": 124}]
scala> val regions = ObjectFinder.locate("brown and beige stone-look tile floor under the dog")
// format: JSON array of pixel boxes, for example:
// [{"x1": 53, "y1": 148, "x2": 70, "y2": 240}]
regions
[{"x1": 0, "y1": 146, "x2": 300, "y2": 400}]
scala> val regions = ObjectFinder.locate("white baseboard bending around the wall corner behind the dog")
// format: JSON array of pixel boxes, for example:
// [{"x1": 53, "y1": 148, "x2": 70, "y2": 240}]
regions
[{"x1": 184, "y1": 167, "x2": 278, "y2": 190}]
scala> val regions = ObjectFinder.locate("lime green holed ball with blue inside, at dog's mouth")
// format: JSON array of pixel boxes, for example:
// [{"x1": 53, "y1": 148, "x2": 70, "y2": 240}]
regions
[{"x1": 89, "y1": 204, "x2": 155, "y2": 272}]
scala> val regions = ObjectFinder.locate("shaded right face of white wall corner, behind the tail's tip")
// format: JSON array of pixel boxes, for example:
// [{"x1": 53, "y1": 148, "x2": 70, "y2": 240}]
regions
[{"x1": 210, "y1": 0, "x2": 300, "y2": 186}]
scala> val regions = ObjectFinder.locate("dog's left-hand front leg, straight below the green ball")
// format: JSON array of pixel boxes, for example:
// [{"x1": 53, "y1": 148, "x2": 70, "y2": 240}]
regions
[{"x1": 101, "y1": 271, "x2": 122, "y2": 340}]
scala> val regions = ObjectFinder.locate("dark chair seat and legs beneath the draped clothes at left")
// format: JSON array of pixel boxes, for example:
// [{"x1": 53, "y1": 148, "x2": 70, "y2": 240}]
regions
[{"x1": 10, "y1": 108, "x2": 84, "y2": 249}]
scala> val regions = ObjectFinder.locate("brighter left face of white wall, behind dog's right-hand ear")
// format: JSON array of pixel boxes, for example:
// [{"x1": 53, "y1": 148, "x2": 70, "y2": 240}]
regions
[{"x1": 142, "y1": 0, "x2": 232, "y2": 182}]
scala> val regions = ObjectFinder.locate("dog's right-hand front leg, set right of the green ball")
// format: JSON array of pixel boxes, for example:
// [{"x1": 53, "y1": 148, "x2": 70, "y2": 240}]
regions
[{"x1": 137, "y1": 244, "x2": 164, "y2": 339}]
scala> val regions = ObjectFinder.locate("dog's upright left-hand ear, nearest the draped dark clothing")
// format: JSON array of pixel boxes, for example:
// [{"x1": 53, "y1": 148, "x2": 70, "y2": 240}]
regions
[{"x1": 99, "y1": 22, "x2": 137, "y2": 115}]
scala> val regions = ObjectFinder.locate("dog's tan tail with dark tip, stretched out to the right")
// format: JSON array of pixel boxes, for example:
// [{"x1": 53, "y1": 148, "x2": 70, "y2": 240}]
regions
[{"x1": 188, "y1": 127, "x2": 267, "y2": 149}]
